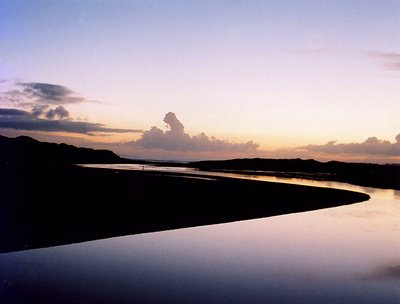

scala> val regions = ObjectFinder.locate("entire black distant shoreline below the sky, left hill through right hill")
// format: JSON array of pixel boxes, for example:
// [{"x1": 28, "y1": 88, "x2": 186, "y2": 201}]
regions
[{"x1": 0, "y1": 135, "x2": 400, "y2": 190}]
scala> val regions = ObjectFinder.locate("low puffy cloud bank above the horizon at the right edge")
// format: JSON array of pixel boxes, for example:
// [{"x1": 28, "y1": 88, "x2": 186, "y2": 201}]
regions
[{"x1": 299, "y1": 134, "x2": 400, "y2": 157}]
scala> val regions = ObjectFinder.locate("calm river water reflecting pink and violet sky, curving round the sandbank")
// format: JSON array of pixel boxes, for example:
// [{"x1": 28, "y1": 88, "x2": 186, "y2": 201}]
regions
[{"x1": 0, "y1": 165, "x2": 400, "y2": 303}]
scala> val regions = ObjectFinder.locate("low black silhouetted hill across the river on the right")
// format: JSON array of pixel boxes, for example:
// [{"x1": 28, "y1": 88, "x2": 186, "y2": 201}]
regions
[{"x1": 188, "y1": 158, "x2": 400, "y2": 189}]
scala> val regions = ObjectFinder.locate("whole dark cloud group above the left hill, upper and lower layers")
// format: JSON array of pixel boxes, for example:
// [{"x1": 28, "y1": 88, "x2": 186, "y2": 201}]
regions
[{"x1": 0, "y1": 82, "x2": 142, "y2": 135}]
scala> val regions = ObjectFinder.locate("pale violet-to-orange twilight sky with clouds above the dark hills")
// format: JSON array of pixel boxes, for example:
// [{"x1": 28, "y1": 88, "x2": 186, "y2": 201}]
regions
[{"x1": 0, "y1": 0, "x2": 400, "y2": 163}]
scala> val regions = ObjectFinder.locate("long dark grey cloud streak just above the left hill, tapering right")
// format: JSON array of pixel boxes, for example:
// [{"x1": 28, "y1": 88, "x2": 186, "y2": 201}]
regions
[{"x1": 0, "y1": 107, "x2": 142, "y2": 135}]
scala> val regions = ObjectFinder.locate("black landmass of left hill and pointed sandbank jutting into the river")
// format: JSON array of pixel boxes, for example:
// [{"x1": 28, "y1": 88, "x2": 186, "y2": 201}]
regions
[{"x1": 0, "y1": 136, "x2": 369, "y2": 252}]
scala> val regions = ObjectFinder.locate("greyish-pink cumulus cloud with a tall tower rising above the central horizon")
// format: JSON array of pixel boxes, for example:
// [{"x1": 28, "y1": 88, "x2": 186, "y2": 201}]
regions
[{"x1": 135, "y1": 112, "x2": 258, "y2": 152}]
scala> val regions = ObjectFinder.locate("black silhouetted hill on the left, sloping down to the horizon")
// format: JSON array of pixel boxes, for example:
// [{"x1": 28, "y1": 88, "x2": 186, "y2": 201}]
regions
[{"x1": 0, "y1": 135, "x2": 129, "y2": 164}]
